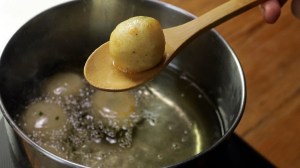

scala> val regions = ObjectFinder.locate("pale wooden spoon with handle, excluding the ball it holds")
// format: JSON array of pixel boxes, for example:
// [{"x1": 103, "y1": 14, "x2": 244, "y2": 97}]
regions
[{"x1": 84, "y1": 0, "x2": 260, "y2": 91}]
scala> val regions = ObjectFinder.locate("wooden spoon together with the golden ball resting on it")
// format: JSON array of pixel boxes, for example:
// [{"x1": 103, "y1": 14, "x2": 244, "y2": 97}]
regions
[{"x1": 84, "y1": 0, "x2": 260, "y2": 91}]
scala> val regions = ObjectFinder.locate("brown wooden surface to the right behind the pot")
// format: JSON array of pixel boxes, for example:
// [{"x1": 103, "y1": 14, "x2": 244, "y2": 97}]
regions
[{"x1": 164, "y1": 0, "x2": 300, "y2": 167}]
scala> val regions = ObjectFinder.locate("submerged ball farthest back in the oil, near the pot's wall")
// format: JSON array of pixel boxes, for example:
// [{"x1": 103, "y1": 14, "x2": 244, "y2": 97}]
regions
[{"x1": 43, "y1": 72, "x2": 84, "y2": 96}]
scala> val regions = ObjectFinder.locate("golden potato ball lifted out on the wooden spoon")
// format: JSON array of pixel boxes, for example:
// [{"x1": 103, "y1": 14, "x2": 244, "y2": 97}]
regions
[{"x1": 109, "y1": 16, "x2": 165, "y2": 73}]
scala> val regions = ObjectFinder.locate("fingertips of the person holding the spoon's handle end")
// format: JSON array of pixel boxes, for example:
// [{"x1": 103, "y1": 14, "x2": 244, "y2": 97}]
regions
[{"x1": 260, "y1": 0, "x2": 300, "y2": 23}]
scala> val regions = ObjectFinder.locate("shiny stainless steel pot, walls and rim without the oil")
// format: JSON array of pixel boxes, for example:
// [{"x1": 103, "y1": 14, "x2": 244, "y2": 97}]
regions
[{"x1": 0, "y1": 0, "x2": 246, "y2": 167}]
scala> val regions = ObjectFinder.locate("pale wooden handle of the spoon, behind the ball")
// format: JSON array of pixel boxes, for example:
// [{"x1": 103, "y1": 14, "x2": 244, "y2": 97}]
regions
[{"x1": 164, "y1": 0, "x2": 261, "y2": 57}]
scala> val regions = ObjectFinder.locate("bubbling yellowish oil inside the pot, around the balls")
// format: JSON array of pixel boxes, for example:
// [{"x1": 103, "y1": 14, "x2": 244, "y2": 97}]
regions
[{"x1": 17, "y1": 67, "x2": 222, "y2": 168}]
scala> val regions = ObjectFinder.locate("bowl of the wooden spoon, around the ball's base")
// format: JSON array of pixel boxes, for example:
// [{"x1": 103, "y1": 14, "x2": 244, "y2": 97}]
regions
[{"x1": 84, "y1": 42, "x2": 169, "y2": 91}]
